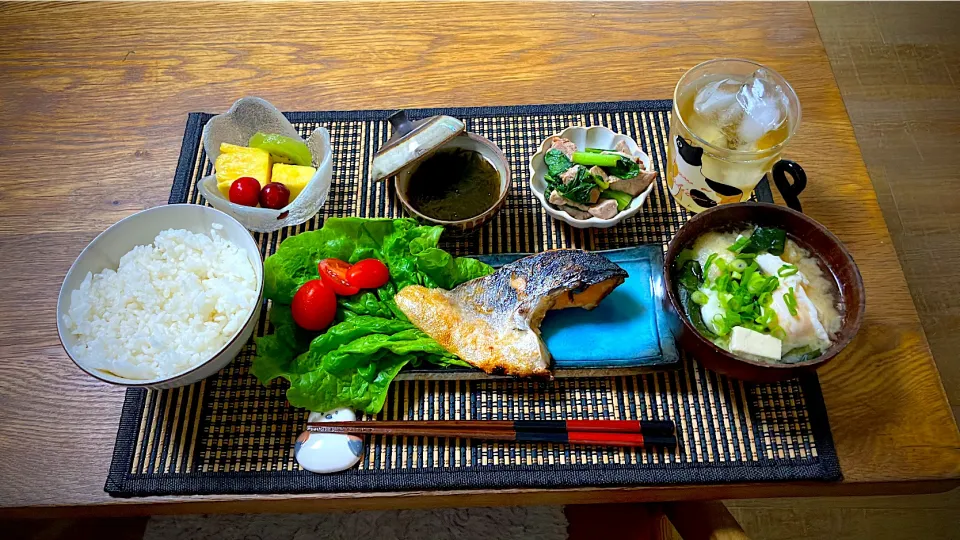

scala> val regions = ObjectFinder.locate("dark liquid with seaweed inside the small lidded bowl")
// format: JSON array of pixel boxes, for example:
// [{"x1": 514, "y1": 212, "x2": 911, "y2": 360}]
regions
[{"x1": 407, "y1": 148, "x2": 500, "y2": 221}]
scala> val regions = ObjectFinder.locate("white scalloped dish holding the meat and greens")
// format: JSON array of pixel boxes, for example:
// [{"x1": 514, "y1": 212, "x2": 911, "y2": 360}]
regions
[{"x1": 530, "y1": 126, "x2": 659, "y2": 229}]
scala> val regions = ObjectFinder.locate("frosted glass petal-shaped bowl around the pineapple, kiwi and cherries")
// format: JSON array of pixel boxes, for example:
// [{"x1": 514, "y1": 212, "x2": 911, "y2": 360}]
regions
[{"x1": 199, "y1": 97, "x2": 333, "y2": 232}]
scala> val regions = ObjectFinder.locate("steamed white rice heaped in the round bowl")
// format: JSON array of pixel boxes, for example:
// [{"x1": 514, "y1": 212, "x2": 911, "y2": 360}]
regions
[{"x1": 63, "y1": 225, "x2": 257, "y2": 380}]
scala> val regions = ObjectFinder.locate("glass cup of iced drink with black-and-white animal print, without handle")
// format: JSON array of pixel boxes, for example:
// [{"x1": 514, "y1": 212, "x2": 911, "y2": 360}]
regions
[{"x1": 667, "y1": 59, "x2": 800, "y2": 212}]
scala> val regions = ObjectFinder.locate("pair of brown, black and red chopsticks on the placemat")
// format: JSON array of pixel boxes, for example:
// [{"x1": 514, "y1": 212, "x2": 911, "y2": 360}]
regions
[{"x1": 307, "y1": 420, "x2": 677, "y2": 448}]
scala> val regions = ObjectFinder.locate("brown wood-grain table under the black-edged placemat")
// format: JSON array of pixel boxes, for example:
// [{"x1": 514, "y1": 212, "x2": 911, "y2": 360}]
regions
[{"x1": 0, "y1": 2, "x2": 960, "y2": 516}]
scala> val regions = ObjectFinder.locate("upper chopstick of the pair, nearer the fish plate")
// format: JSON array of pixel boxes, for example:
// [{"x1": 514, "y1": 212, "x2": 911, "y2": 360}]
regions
[{"x1": 307, "y1": 420, "x2": 676, "y2": 435}]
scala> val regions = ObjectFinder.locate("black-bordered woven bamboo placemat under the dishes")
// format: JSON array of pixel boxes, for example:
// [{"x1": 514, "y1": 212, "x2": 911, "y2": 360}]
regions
[{"x1": 105, "y1": 101, "x2": 840, "y2": 497}]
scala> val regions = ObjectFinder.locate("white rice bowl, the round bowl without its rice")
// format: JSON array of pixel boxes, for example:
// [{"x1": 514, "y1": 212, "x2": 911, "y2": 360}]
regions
[{"x1": 57, "y1": 204, "x2": 263, "y2": 389}]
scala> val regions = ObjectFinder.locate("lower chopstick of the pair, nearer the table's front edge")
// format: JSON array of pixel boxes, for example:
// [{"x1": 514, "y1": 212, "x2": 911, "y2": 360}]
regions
[{"x1": 307, "y1": 421, "x2": 677, "y2": 447}]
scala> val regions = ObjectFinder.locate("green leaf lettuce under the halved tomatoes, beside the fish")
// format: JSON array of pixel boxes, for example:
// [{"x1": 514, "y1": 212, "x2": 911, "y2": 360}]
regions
[{"x1": 251, "y1": 218, "x2": 493, "y2": 414}]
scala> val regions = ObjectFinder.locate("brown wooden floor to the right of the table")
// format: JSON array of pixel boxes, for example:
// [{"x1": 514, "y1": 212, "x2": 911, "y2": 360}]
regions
[{"x1": 815, "y1": 2, "x2": 960, "y2": 414}]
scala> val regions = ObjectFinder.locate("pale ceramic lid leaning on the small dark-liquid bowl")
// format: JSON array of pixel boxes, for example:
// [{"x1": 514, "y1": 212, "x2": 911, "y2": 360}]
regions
[{"x1": 370, "y1": 110, "x2": 466, "y2": 181}]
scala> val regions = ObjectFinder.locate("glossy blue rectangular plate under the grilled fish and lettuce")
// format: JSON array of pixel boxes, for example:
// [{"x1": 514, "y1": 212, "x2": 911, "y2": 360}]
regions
[{"x1": 398, "y1": 245, "x2": 680, "y2": 380}]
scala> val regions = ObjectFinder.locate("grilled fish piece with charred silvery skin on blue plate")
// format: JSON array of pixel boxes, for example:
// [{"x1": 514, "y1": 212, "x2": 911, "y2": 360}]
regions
[{"x1": 394, "y1": 249, "x2": 627, "y2": 377}]
